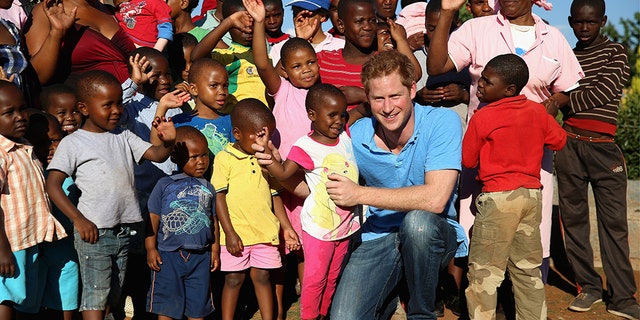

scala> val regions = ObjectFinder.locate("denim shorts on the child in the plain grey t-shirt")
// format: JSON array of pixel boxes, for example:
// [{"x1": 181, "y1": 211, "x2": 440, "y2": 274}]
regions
[{"x1": 74, "y1": 224, "x2": 131, "y2": 311}]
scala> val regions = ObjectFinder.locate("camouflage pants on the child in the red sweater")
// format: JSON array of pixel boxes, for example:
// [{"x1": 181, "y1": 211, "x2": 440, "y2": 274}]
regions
[{"x1": 465, "y1": 188, "x2": 547, "y2": 320}]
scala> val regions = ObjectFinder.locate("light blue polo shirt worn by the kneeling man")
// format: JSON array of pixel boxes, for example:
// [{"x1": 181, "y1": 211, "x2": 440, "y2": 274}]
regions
[{"x1": 351, "y1": 104, "x2": 468, "y2": 256}]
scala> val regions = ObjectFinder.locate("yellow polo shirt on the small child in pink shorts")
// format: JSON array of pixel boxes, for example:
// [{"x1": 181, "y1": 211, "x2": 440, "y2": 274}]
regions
[{"x1": 211, "y1": 143, "x2": 280, "y2": 245}]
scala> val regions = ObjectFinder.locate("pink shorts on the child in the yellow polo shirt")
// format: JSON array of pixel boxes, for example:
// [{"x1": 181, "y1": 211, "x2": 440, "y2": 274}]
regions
[{"x1": 220, "y1": 243, "x2": 282, "y2": 272}]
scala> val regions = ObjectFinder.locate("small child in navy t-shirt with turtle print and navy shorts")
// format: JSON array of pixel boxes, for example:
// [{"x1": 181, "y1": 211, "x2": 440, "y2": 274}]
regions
[{"x1": 145, "y1": 127, "x2": 220, "y2": 320}]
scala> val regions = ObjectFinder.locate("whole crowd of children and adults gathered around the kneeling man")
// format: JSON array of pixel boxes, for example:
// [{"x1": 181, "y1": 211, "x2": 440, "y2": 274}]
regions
[{"x1": 0, "y1": 0, "x2": 640, "y2": 320}]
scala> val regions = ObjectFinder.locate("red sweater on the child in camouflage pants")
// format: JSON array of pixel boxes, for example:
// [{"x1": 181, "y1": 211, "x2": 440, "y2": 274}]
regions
[{"x1": 462, "y1": 95, "x2": 567, "y2": 192}]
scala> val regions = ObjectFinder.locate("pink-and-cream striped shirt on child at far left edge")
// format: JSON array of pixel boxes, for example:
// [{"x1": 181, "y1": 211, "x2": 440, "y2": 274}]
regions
[{"x1": 0, "y1": 135, "x2": 67, "y2": 252}]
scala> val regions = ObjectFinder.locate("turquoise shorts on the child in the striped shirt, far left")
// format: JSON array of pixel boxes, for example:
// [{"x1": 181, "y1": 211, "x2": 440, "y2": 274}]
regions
[{"x1": 0, "y1": 246, "x2": 40, "y2": 313}]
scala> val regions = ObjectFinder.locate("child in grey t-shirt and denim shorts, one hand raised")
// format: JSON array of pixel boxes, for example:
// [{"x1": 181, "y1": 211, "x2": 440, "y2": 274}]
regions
[{"x1": 47, "y1": 71, "x2": 175, "y2": 319}]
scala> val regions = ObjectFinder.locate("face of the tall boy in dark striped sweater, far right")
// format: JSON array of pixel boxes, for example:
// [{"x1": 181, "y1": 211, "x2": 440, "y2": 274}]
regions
[{"x1": 569, "y1": 5, "x2": 607, "y2": 47}]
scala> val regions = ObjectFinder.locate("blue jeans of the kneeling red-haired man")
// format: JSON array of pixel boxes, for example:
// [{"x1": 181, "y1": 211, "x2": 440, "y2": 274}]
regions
[{"x1": 331, "y1": 210, "x2": 458, "y2": 320}]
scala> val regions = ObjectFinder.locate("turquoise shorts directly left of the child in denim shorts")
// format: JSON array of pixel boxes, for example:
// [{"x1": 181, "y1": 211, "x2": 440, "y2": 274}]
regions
[{"x1": 38, "y1": 236, "x2": 80, "y2": 311}]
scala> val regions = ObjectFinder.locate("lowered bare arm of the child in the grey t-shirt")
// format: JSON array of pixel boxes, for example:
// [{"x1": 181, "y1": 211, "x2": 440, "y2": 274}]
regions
[{"x1": 47, "y1": 170, "x2": 98, "y2": 244}]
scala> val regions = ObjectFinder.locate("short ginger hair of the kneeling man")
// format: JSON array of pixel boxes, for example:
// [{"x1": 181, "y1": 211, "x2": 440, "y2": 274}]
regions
[{"x1": 361, "y1": 50, "x2": 415, "y2": 93}]
